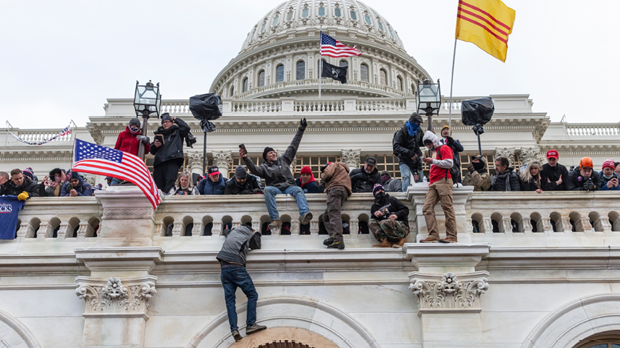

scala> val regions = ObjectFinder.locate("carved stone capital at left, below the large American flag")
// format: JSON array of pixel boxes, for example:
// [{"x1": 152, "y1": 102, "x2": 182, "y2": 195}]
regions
[{"x1": 75, "y1": 276, "x2": 157, "y2": 315}]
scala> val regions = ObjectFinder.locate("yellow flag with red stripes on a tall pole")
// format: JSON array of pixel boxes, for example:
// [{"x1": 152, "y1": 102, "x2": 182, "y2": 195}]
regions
[{"x1": 456, "y1": 0, "x2": 516, "y2": 62}]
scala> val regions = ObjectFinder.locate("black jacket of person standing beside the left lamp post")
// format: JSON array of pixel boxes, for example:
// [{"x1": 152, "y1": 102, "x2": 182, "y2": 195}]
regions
[{"x1": 151, "y1": 118, "x2": 190, "y2": 166}]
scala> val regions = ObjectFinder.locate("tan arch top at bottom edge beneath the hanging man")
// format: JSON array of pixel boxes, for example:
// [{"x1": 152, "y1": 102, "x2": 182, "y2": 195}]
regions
[{"x1": 230, "y1": 327, "x2": 338, "y2": 348}]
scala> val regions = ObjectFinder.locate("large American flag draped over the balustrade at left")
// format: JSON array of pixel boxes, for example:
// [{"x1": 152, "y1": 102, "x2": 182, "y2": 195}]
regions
[{"x1": 72, "y1": 139, "x2": 161, "y2": 209}]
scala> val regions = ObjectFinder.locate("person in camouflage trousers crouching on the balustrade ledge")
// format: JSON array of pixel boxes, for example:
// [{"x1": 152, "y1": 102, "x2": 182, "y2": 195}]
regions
[{"x1": 368, "y1": 184, "x2": 409, "y2": 248}]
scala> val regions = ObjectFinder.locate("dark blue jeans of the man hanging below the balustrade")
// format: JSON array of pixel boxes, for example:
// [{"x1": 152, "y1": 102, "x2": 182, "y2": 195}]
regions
[{"x1": 220, "y1": 266, "x2": 258, "y2": 332}]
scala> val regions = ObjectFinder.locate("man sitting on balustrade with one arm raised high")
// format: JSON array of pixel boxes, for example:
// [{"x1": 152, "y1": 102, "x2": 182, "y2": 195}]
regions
[{"x1": 239, "y1": 118, "x2": 312, "y2": 231}]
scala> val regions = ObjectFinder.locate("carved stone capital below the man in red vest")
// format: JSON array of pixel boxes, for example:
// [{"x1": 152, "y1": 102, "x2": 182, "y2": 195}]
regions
[{"x1": 409, "y1": 271, "x2": 489, "y2": 312}]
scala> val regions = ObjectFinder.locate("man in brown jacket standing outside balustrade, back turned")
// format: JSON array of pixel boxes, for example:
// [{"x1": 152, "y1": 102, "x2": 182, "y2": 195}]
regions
[{"x1": 321, "y1": 162, "x2": 351, "y2": 250}]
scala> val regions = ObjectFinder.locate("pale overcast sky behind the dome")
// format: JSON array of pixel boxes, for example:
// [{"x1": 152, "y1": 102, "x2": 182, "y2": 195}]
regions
[{"x1": 0, "y1": 0, "x2": 620, "y2": 128}]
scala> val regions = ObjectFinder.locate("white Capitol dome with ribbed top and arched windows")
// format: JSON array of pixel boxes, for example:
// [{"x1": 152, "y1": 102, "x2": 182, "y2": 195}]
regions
[{"x1": 211, "y1": 0, "x2": 430, "y2": 100}]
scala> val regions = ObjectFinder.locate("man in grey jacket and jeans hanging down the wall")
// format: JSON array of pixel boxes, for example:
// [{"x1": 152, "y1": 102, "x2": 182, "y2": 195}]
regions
[{"x1": 217, "y1": 225, "x2": 267, "y2": 341}]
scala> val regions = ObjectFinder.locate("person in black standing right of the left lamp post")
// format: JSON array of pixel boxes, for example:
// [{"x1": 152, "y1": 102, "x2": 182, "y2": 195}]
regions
[{"x1": 151, "y1": 112, "x2": 190, "y2": 192}]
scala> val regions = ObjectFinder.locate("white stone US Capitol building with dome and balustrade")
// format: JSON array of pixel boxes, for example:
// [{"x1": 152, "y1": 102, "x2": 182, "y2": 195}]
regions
[{"x1": 0, "y1": 0, "x2": 620, "y2": 348}]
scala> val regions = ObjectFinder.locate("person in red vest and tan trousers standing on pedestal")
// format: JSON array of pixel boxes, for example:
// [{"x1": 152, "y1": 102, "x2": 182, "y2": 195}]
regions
[{"x1": 420, "y1": 131, "x2": 458, "y2": 243}]
